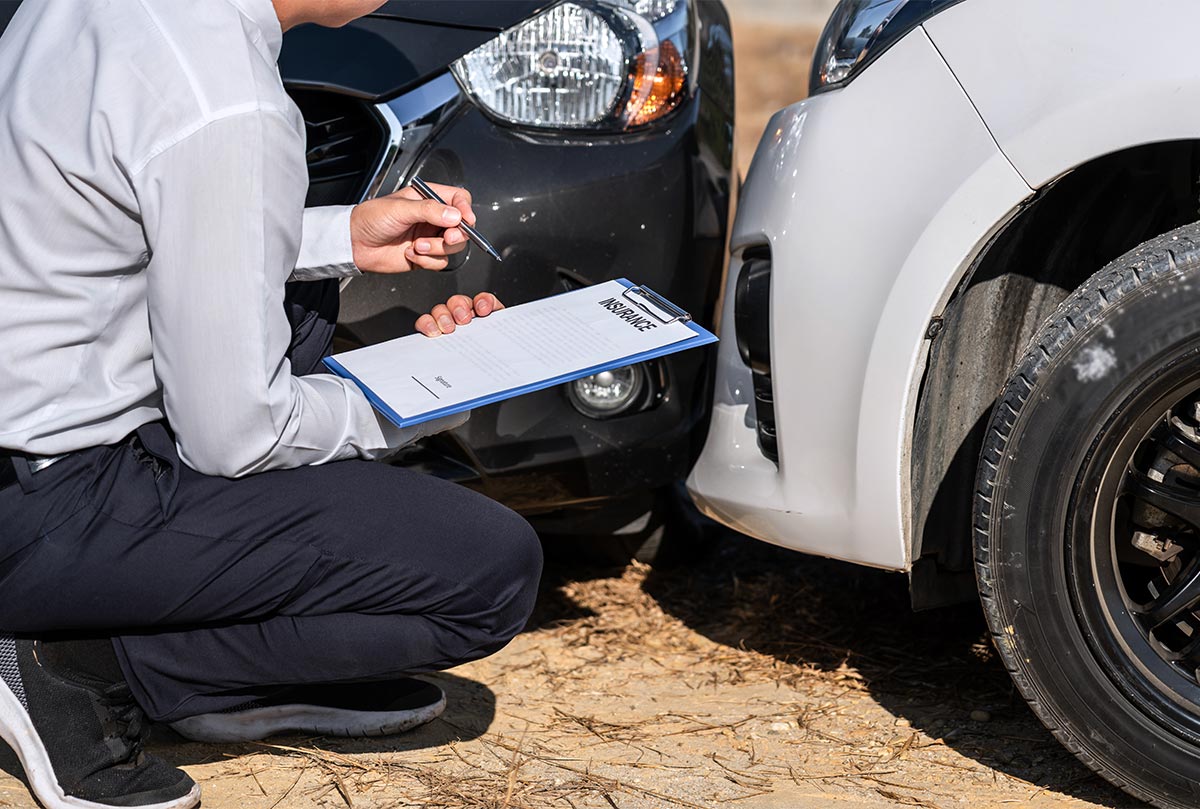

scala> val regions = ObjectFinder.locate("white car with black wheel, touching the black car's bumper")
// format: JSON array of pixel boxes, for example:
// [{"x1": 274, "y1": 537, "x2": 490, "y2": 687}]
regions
[{"x1": 688, "y1": 0, "x2": 1200, "y2": 807}]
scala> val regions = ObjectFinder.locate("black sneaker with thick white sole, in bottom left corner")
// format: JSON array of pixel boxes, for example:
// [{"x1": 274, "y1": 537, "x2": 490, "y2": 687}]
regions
[{"x1": 0, "y1": 635, "x2": 200, "y2": 809}]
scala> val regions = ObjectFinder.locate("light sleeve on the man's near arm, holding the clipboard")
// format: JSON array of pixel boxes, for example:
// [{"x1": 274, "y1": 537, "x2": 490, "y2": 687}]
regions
[{"x1": 133, "y1": 109, "x2": 464, "y2": 478}]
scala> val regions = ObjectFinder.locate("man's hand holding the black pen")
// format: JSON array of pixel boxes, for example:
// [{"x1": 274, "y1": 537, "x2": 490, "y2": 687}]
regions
[{"x1": 350, "y1": 182, "x2": 475, "y2": 272}]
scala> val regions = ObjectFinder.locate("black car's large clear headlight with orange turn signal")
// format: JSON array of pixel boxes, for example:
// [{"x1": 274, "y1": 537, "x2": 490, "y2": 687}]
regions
[{"x1": 451, "y1": 0, "x2": 688, "y2": 130}]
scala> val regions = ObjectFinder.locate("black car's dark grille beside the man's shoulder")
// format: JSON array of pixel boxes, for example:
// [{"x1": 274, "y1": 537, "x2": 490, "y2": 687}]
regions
[{"x1": 290, "y1": 90, "x2": 385, "y2": 208}]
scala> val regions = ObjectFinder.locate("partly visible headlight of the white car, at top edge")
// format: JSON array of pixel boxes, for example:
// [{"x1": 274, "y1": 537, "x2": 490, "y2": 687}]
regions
[{"x1": 809, "y1": 0, "x2": 961, "y2": 94}]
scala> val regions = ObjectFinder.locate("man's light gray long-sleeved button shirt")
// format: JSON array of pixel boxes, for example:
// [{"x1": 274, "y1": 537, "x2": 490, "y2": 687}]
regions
[{"x1": 0, "y1": 0, "x2": 462, "y2": 477}]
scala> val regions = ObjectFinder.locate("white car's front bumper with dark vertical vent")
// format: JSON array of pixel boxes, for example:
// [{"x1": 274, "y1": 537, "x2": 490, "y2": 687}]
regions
[{"x1": 688, "y1": 29, "x2": 1031, "y2": 569}]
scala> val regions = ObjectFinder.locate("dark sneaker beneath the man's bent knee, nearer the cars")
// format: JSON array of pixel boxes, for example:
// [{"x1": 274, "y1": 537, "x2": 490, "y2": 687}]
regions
[{"x1": 170, "y1": 678, "x2": 446, "y2": 742}]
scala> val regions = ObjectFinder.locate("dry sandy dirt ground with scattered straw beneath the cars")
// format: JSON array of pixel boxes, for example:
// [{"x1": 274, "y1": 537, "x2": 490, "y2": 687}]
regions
[{"x1": 0, "y1": 14, "x2": 1139, "y2": 809}]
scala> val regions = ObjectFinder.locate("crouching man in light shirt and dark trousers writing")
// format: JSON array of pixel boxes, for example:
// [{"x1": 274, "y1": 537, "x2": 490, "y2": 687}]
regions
[{"x1": 0, "y1": 0, "x2": 541, "y2": 809}]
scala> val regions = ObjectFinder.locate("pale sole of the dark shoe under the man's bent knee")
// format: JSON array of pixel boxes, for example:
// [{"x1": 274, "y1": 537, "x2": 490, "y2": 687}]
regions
[{"x1": 170, "y1": 695, "x2": 446, "y2": 742}]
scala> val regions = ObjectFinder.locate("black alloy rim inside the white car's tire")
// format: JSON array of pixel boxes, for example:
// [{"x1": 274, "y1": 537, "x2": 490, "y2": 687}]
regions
[{"x1": 1064, "y1": 354, "x2": 1200, "y2": 743}]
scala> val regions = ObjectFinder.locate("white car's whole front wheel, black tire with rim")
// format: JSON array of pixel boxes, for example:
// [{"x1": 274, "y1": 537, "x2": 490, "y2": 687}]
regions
[{"x1": 974, "y1": 224, "x2": 1200, "y2": 807}]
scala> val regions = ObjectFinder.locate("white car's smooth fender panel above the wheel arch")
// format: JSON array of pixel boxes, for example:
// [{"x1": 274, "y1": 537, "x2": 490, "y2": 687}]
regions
[{"x1": 926, "y1": 0, "x2": 1200, "y2": 188}]
